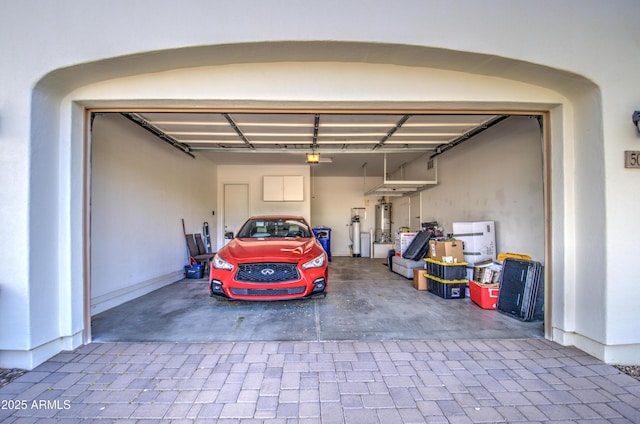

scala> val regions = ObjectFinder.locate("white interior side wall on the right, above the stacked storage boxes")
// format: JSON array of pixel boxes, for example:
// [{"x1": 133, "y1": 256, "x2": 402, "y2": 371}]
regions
[{"x1": 393, "y1": 116, "x2": 545, "y2": 263}]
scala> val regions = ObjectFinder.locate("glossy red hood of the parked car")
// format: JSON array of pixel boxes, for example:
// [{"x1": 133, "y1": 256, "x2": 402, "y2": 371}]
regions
[{"x1": 218, "y1": 238, "x2": 322, "y2": 262}]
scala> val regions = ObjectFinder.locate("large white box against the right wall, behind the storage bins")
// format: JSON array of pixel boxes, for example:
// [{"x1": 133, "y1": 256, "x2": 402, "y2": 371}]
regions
[{"x1": 453, "y1": 221, "x2": 496, "y2": 264}]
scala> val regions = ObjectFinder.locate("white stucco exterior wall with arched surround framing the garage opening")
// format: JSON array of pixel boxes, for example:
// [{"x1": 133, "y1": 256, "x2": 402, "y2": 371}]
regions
[{"x1": 0, "y1": 0, "x2": 640, "y2": 367}]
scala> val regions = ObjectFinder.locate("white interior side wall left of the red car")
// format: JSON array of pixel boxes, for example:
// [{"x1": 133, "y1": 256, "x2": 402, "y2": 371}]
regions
[{"x1": 91, "y1": 114, "x2": 217, "y2": 314}]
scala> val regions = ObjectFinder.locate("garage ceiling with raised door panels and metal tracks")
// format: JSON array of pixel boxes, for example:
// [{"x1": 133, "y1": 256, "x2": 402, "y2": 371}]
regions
[{"x1": 122, "y1": 112, "x2": 505, "y2": 176}]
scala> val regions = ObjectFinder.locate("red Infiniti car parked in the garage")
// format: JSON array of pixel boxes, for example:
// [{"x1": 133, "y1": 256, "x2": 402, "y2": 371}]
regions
[{"x1": 209, "y1": 216, "x2": 328, "y2": 300}]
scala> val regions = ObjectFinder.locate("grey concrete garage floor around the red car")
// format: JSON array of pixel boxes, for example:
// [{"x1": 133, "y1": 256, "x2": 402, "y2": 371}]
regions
[{"x1": 92, "y1": 257, "x2": 544, "y2": 342}]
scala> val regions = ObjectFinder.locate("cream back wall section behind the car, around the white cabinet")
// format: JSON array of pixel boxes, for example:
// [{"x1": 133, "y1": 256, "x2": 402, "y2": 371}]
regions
[{"x1": 214, "y1": 165, "x2": 311, "y2": 248}]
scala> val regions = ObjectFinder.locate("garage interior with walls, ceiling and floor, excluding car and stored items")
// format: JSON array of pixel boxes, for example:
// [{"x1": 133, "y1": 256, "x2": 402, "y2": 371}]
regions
[{"x1": 87, "y1": 108, "x2": 545, "y2": 341}]
